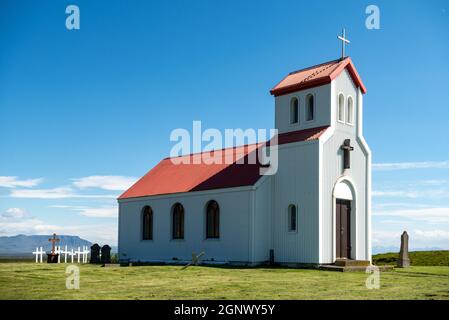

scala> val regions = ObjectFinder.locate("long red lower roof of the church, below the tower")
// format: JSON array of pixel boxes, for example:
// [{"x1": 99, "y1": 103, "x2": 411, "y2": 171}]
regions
[{"x1": 119, "y1": 127, "x2": 328, "y2": 199}]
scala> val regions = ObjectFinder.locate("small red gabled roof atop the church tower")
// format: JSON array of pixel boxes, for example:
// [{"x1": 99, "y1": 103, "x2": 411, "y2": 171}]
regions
[{"x1": 270, "y1": 57, "x2": 366, "y2": 97}]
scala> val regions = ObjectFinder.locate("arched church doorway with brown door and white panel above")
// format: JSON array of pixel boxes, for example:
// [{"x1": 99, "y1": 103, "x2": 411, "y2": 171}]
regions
[{"x1": 333, "y1": 179, "x2": 356, "y2": 259}]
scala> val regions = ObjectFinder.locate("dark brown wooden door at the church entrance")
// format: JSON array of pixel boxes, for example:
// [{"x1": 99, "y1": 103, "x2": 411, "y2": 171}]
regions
[{"x1": 336, "y1": 199, "x2": 351, "y2": 259}]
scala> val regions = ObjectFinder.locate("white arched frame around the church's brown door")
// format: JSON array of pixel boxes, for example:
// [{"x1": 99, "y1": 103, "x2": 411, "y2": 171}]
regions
[{"x1": 331, "y1": 176, "x2": 358, "y2": 262}]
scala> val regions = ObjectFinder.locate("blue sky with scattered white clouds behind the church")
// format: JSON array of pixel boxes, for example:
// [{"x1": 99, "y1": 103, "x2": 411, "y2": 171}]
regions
[{"x1": 0, "y1": 0, "x2": 449, "y2": 249}]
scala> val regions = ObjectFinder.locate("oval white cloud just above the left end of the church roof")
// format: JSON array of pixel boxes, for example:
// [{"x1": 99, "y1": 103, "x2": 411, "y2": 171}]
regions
[{"x1": 72, "y1": 176, "x2": 137, "y2": 191}]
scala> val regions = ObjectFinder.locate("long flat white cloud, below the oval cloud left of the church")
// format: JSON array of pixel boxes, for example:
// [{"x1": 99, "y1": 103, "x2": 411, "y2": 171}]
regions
[{"x1": 10, "y1": 187, "x2": 117, "y2": 199}]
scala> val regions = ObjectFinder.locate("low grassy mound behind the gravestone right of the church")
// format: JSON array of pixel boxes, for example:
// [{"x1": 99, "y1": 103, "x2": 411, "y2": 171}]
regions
[{"x1": 373, "y1": 250, "x2": 449, "y2": 266}]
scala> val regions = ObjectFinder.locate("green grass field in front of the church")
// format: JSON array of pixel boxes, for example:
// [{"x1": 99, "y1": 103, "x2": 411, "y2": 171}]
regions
[{"x1": 0, "y1": 263, "x2": 449, "y2": 300}]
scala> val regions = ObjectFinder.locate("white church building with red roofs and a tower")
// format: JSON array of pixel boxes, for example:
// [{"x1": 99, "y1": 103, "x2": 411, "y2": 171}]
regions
[{"x1": 118, "y1": 57, "x2": 371, "y2": 266}]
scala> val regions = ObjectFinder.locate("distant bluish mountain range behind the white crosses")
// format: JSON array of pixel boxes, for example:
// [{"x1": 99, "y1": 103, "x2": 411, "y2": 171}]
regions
[{"x1": 0, "y1": 234, "x2": 92, "y2": 256}]
